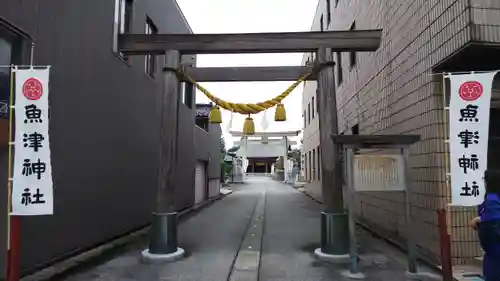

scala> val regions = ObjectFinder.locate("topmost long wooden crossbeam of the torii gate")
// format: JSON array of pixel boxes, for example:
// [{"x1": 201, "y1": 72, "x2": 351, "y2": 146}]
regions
[{"x1": 118, "y1": 30, "x2": 382, "y2": 55}]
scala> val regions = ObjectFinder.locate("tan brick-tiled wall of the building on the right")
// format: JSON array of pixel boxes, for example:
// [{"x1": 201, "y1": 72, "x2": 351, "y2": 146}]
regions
[{"x1": 304, "y1": 0, "x2": 500, "y2": 264}]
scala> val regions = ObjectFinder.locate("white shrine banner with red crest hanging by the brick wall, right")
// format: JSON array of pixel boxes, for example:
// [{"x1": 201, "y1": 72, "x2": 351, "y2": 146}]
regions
[{"x1": 447, "y1": 72, "x2": 497, "y2": 206}]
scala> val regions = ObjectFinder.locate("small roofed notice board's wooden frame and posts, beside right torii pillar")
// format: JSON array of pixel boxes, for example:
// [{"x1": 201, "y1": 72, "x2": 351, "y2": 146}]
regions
[{"x1": 332, "y1": 135, "x2": 420, "y2": 280}]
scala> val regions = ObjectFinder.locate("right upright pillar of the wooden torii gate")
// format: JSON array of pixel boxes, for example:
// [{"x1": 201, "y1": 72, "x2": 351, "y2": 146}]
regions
[{"x1": 315, "y1": 48, "x2": 349, "y2": 261}]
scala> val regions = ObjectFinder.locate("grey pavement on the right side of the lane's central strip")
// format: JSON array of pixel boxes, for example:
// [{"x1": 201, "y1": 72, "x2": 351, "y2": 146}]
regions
[{"x1": 260, "y1": 178, "x2": 441, "y2": 281}]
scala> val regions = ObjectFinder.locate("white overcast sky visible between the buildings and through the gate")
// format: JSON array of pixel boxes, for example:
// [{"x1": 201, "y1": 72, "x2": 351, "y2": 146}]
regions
[{"x1": 177, "y1": 0, "x2": 318, "y2": 148}]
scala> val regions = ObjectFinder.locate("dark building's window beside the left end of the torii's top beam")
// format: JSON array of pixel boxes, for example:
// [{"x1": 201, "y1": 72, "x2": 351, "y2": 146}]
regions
[{"x1": 113, "y1": 0, "x2": 134, "y2": 61}]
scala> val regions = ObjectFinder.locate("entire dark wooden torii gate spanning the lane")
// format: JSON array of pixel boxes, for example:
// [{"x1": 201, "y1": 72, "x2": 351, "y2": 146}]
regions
[{"x1": 119, "y1": 30, "x2": 382, "y2": 261}]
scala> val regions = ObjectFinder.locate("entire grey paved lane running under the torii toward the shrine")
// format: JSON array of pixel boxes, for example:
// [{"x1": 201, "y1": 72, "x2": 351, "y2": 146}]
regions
[{"x1": 57, "y1": 178, "x2": 441, "y2": 281}]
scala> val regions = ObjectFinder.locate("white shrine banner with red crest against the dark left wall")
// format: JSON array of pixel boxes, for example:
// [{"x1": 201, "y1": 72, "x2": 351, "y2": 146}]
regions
[{"x1": 12, "y1": 68, "x2": 54, "y2": 216}]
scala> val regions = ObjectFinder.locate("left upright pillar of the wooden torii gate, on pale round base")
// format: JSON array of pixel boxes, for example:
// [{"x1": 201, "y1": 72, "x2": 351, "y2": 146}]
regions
[{"x1": 141, "y1": 50, "x2": 184, "y2": 262}]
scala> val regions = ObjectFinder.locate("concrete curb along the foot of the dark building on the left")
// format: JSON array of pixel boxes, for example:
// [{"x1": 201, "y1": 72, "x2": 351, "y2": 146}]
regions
[{"x1": 21, "y1": 190, "x2": 233, "y2": 281}]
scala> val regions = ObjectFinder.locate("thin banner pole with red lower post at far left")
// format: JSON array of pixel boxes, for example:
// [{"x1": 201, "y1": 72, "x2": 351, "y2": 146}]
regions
[{"x1": 6, "y1": 66, "x2": 21, "y2": 281}]
